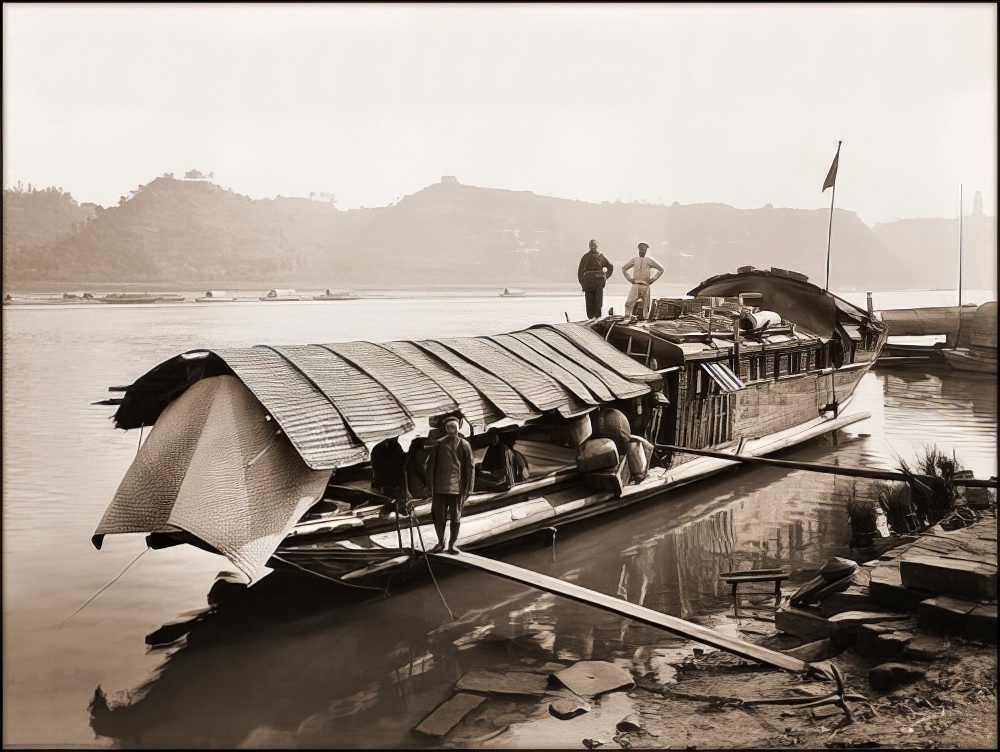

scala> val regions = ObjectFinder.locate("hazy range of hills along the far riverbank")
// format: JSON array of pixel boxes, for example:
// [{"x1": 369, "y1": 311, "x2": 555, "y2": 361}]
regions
[{"x1": 3, "y1": 176, "x2": 996, "y2": 290}]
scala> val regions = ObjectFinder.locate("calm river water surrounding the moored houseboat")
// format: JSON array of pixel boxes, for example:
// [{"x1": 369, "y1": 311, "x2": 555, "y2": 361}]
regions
[{"x1": 3, "y1": 288, "x2": 997, "y2": 749}]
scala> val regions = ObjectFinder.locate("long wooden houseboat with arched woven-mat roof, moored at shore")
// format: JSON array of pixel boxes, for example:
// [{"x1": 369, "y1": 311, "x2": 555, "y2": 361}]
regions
[{"x1": 93, "y1": 267, "x2": 886, "y2": 586}]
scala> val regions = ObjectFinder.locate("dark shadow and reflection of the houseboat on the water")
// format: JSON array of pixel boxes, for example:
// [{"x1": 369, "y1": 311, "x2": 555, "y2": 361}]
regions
[{"x1": 90, "y1": 437, "x2": 863, "y2": 748}]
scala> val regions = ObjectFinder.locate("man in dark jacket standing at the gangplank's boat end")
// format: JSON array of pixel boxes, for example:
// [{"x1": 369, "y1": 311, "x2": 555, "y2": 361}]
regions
[{"x1": 427, "y1": 416, "x2": 476, "y2": 554}]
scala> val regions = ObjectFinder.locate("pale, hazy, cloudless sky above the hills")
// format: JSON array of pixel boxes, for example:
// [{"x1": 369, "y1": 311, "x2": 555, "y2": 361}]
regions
[{"x1": 3, "y1": 3, "x2": 997, "y2": 224}]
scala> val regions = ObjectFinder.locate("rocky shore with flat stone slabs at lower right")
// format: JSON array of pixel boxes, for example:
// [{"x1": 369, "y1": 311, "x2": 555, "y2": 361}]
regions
[{"x1": 416, "y1": 505, "x2": 997, "y2": 749}]
